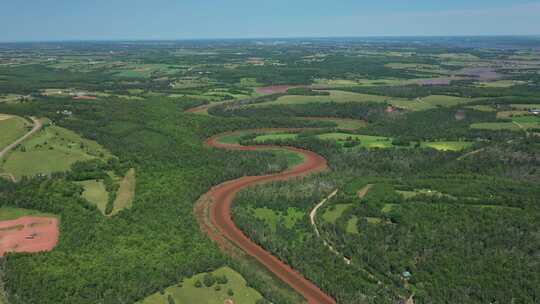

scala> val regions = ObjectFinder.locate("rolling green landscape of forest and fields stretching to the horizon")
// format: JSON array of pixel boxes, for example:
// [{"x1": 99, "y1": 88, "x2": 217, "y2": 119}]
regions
[{"x1": 0, "y1": 37, "x2": 540, "y2": 304}]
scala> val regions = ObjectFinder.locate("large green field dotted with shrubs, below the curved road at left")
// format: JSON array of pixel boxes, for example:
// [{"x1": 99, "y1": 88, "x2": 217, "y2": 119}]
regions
[{"x1": 1, "y1": 126, "x2": 112, "y2": 178}]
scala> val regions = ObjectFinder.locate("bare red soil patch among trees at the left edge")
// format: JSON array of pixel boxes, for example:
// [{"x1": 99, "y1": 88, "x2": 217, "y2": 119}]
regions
[{"x1": 0, "y1": 216, "x2": 60, "y2": 256}]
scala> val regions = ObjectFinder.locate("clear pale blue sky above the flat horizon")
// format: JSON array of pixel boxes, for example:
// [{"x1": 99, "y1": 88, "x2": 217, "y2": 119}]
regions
[{"x1": 0, "y1": 0, "x2": 540, "y2": 41}]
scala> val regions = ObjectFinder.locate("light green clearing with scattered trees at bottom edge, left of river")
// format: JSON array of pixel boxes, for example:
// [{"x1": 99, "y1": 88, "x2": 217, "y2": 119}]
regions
[{"x1": 138, "y1": 267, "x2": 262, "y2": 304}]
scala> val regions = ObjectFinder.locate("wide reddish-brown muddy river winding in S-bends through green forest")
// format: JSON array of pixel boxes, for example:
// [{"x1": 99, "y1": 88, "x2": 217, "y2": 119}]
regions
[{"x1": 199, "y1": 130, "x2": 336, "y2": 304}]
